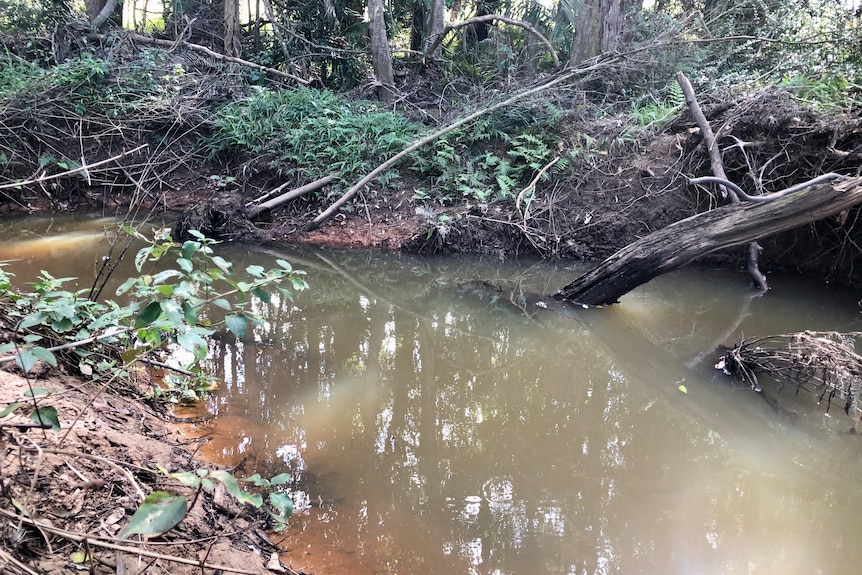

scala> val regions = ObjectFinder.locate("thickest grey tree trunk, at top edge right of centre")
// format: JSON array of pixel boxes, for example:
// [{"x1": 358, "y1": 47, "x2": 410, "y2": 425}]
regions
[{"x1": 569, "y1": 0, "x2": 623, "y2": 65}]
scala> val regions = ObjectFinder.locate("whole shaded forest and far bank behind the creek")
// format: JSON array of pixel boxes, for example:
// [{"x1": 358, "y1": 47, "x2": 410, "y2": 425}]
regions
[{"x1": 5, "y1": 0, "x2": 862, "y2": 283}]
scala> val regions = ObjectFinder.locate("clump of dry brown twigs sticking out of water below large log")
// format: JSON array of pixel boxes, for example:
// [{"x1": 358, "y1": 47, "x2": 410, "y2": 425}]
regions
[{"x1": 717, "y1": 331, "x2": 862, "y2": 419}]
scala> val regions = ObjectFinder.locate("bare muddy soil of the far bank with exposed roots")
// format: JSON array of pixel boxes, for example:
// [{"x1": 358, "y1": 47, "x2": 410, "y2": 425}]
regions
[{"x1": 6, "y1": 89, "x2": 862, "y2": 284}]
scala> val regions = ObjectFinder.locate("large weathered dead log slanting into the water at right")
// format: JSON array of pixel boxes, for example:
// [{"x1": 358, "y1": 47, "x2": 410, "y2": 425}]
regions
[{"x1": 554, "y1": 177, "x2": 862, "y2": 305}]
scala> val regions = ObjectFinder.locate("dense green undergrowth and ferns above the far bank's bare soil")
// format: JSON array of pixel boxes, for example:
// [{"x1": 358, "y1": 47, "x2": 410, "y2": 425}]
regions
[{"x1": 0, "y1": 0, "x2": 862, "y2": 214}]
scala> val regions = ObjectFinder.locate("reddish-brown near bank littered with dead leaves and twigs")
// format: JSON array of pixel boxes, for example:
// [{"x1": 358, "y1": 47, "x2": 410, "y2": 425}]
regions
[{"x1": 0, "y1": 363, "x2": 300, "y2": 575}]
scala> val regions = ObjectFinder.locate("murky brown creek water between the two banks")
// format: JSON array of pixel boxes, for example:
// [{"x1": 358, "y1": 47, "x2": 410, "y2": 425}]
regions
[{"x1": 5, "y1": 218, "x2": 862, "y2": 575}]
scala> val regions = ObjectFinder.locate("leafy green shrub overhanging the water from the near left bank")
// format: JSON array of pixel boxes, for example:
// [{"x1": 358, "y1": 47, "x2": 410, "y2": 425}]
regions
[{"x1": 0, "y1": 227, "x2": 307, "y2": 420}]
